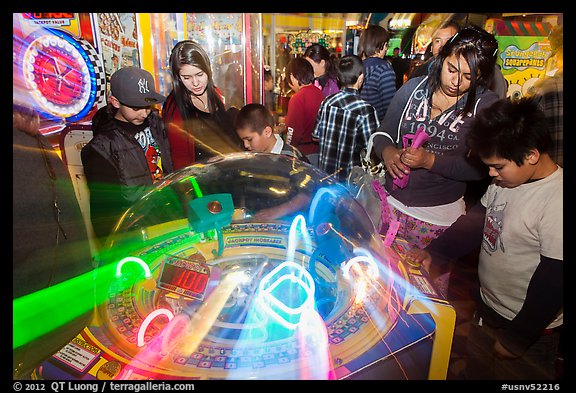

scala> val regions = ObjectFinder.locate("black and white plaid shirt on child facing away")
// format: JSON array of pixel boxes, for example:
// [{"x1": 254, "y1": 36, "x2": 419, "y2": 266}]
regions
[{"x1": 312, "y1": 87, "x2": 380, "y2": 181}]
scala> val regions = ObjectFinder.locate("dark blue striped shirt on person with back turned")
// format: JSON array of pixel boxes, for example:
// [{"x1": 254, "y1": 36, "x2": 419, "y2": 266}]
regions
[{"x1": 360, "y1": 57, "x2": 396, "y2": 122}]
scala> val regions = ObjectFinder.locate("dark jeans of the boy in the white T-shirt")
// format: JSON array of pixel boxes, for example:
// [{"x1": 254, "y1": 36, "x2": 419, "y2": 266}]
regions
[{"x1": 465, "y1": 315, "x2": 560, "y2": 380}]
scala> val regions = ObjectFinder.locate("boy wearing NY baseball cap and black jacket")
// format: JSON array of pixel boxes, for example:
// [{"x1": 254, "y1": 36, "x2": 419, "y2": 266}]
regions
[{"x1": 81, "y1": 67, "x2": 172, "y2": 241}]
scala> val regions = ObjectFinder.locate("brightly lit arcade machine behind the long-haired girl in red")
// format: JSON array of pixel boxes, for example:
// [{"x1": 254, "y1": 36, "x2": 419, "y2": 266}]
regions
[{"x1": 134, "y1": 13, "x2": 264, "y2": 109}]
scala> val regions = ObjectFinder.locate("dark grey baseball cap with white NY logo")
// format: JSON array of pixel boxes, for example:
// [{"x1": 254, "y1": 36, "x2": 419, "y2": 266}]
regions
[{"x1": 110, "y1": 67, "x2": 166, "y2": 107}]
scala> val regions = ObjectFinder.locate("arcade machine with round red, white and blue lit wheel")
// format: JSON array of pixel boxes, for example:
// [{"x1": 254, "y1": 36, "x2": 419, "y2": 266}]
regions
[{"x1": 12, "y1": 13, "x2": 106, "y2": 258}]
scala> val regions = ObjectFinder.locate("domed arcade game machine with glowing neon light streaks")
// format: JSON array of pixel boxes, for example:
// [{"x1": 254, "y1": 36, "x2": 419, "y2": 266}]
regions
[{"x1": 23, "y1": 152, "x2": 455, "y2": 381}]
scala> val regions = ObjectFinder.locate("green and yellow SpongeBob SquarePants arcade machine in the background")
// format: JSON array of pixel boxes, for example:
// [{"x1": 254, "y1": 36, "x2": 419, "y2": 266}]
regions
[{"x1": 485, "y1": 19, "x2": 552, "y2": 99}]
